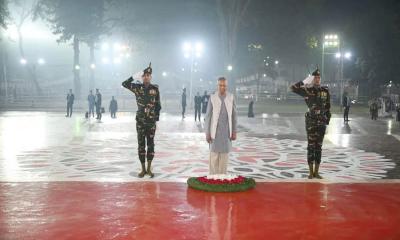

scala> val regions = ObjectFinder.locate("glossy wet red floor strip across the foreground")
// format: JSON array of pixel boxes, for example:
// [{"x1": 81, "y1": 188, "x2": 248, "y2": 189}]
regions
[{"x1": 0, "y1": 182, "x2": 400, "y2": 240}]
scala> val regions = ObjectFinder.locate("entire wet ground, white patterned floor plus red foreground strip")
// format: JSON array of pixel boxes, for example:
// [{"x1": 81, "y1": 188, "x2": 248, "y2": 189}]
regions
[{"x1": 0, "y1": 112, "x2": 400, "y2": 240}]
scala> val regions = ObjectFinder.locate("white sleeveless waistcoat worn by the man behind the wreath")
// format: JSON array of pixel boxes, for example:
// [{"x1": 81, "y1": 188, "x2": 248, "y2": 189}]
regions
[{"x1": 210, "y1": 92, "x2": 233, "y2": 139}]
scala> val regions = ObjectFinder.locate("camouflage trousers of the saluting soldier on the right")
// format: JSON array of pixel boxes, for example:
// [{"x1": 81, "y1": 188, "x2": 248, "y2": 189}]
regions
[{"x1": 306, "y1": 118, "x2": 326, "y2": 164}]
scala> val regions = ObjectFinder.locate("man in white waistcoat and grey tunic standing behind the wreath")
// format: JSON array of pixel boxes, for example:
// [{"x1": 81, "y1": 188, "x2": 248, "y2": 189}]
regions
[{"x1": 205, "y1": 77, "x2": 237, "y2": 175}]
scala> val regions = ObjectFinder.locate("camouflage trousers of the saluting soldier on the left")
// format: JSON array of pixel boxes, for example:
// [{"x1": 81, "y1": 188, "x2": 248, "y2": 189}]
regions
[{"x1": 136, "y1": 121, "x2": 156, "y2": 163}]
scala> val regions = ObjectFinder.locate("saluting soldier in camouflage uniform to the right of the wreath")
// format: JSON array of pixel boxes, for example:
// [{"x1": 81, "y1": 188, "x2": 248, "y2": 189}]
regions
[{"x1": 291, "y1": 69, "x2": 331, "y2": 179}]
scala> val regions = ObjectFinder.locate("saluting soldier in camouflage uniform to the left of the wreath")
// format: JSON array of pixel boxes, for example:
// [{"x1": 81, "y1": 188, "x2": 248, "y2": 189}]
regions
[{"x1": 122, "y1": 63, "x2": 161, "y2": 178}]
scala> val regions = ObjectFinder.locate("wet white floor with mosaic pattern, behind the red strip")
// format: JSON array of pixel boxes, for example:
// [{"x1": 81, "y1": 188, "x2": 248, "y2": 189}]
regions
[{"x1": 0, "y1": 113, "x2": 396, "y2": 182}]
